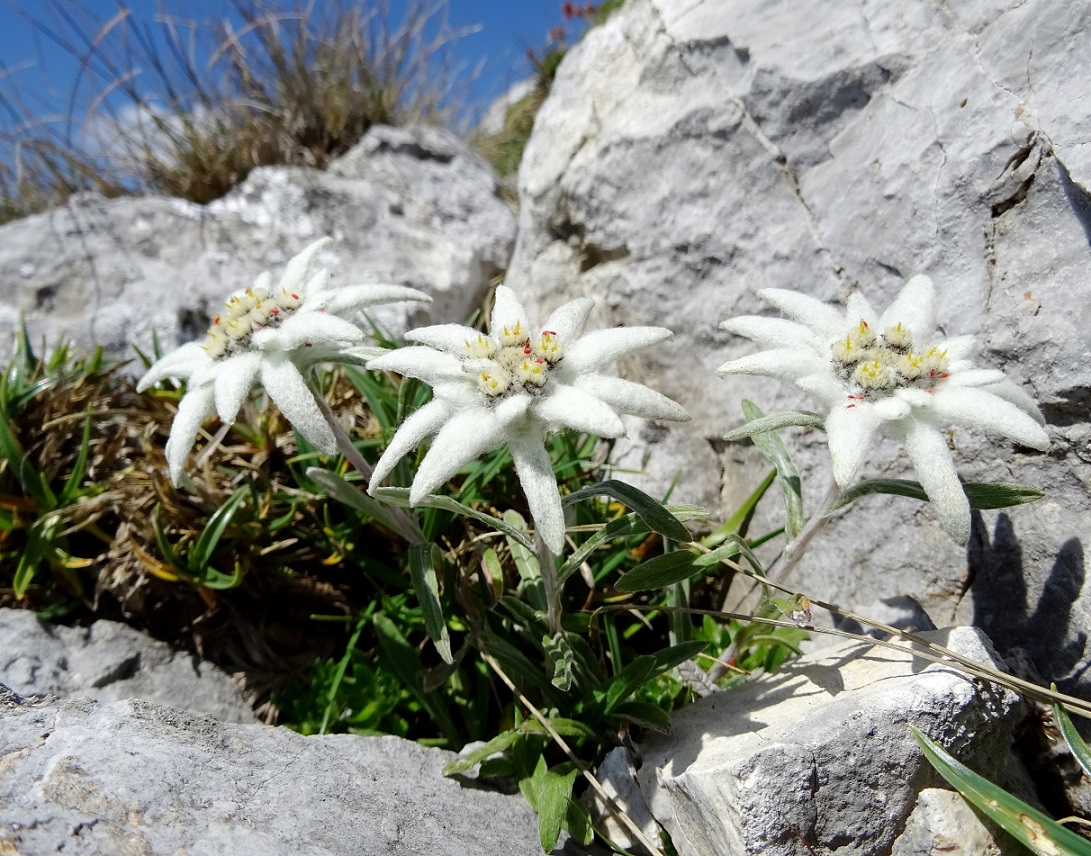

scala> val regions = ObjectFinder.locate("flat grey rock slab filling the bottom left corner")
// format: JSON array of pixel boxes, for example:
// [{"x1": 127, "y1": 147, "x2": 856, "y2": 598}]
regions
[{"x1": 0, "y1": 694, "x2": 554, "y2": 856}]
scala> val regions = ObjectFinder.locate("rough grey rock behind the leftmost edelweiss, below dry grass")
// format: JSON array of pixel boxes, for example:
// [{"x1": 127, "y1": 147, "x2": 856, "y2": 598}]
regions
[{"x1": 0, "y1": 122, "x2": 515, "y2": 358}]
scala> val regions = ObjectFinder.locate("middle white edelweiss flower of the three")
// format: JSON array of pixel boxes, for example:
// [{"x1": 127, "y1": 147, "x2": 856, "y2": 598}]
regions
[{"x1": 368, "y1": 286, "x2": 690, "y2": 553}]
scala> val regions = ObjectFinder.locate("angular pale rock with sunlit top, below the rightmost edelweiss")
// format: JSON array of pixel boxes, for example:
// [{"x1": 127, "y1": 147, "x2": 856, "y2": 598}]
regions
[{"x1": 638, "y1": 628, "x2": 1019, "y2": 856}]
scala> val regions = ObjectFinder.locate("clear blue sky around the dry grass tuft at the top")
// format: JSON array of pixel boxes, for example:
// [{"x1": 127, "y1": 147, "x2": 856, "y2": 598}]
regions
[{"x1": 0, "y1": 0, "x2": 562, "y2": 138}]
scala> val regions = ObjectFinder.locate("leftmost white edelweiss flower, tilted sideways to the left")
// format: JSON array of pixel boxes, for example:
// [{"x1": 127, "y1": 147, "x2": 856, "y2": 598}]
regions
[{"x1": 136, "y1": 238, "x2": 430, "y2": 484}]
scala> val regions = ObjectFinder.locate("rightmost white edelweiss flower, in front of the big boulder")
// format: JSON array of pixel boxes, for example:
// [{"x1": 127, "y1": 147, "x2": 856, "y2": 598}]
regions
[{"x1": 719, "y1": 276, "x2": 1050, "y2": 544}]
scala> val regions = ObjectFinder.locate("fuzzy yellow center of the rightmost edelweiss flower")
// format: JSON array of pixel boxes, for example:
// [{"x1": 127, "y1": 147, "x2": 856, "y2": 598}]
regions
[{"x1": 830, "y1": 321, "x2": 947, "y2": 399}]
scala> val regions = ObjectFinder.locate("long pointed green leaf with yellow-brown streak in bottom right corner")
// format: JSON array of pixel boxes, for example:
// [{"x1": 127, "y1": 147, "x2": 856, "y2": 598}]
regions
[{"x1": 910, "y1": 725, "x2": 1091, "y2": 856}]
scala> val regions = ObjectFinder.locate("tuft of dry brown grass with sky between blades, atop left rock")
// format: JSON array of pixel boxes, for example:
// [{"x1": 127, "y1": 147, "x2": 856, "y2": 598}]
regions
[{"x1": 0, "y1": 0, "x2": 459, "y2": 222}]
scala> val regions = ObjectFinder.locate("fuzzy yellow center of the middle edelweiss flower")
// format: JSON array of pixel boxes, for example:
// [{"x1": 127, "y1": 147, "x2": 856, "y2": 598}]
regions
[{"x1": 463, "y1": 324, "x2": 564, "y2": 398}]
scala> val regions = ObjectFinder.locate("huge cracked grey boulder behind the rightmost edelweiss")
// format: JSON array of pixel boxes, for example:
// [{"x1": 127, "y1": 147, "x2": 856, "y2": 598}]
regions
[{"x1": 507, "y1": 0, "x2": 1091, "y2": 689}]
